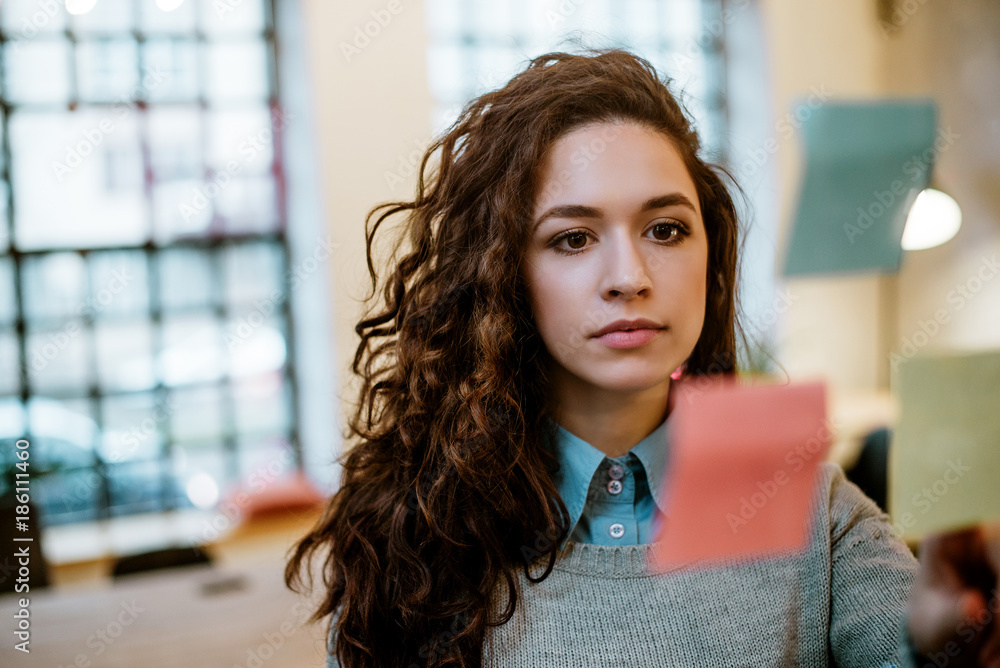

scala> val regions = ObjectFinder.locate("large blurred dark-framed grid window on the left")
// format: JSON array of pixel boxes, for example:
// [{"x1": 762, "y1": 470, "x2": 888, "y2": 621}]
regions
[{"x1": 0, "y1": 0, "x2": 301, "y2": 525}]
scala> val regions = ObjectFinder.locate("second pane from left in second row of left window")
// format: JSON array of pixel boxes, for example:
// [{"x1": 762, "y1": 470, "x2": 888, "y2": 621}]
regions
[{"x1": 76, "y1": 39, "x2": 145, "y2": 102}]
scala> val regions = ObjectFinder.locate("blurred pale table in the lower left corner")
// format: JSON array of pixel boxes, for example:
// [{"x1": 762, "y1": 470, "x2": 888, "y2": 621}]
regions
[{"x1": 0, "y1": 561, "x2": 326, "y2": 668}]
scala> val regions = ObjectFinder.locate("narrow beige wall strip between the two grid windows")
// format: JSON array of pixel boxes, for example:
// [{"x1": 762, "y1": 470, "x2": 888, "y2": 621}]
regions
[{"x1": 303, "y1": 0, "x2": 432, "y2": 430}]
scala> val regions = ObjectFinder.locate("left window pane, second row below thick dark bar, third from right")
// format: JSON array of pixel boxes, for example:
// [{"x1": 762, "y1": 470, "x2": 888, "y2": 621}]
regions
[{"x1": 94, "y1": 320, "x2": 156, "y2": 392}]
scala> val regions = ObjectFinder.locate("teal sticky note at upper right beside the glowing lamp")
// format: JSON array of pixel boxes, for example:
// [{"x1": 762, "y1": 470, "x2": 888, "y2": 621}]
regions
[{"x1": 783, "y1": 100, "x2": 950, "y2": 276}]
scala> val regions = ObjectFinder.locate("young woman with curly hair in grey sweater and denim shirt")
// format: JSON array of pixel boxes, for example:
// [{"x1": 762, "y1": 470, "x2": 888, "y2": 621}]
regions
[{"x1": 286, "y1": 49, "x2": 992, "y2": 668}]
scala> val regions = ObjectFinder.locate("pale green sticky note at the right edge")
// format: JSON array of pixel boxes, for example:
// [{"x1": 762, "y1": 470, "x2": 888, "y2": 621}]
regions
[{"x1": 889, "y1": 351, "x2": 1000, "y2": 540}]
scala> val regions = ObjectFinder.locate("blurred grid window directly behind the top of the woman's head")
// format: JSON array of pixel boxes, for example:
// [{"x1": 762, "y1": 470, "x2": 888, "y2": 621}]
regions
[{"x1": 427, "y1": 0, "x2": 727, "y2": 162}]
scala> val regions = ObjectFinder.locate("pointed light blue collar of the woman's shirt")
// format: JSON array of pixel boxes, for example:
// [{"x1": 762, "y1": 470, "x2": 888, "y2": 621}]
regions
[{"x1": 549, "y1": 418, "x2": 669, "y2": 548}]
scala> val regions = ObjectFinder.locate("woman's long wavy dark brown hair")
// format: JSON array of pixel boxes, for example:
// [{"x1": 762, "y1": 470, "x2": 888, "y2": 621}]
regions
[{"x1": 285, "y1": 44, "x2": 739, "y2": 668}]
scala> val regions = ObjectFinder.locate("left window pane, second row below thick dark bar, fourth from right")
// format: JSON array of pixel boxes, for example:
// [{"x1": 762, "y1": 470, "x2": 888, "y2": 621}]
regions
[{"x1": 27, "y1": 320, "x2": 92, "y2": 394}]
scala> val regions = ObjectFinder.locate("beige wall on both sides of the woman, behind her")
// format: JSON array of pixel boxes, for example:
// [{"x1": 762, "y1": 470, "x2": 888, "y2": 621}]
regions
[{"x1": 303, "y1": 0, "x2": 1000, "y2": 434}]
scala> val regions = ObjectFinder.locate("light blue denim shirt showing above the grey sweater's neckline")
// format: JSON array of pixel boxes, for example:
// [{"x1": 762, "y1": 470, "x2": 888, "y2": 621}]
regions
[{"x1": 554, "y1": 418, "x2": 669, "y2": 546}]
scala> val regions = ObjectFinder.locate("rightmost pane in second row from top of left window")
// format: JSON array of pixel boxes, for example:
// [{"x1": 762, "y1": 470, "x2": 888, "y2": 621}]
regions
[{"x1": 205, "y1": 41, "x2": 269, "y2": 103}]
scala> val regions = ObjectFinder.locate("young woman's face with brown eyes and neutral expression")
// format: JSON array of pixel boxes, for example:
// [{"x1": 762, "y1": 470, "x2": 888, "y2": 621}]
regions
[{"x1": 524, "y1": 123, "x2": 708, "y2": 392}]
